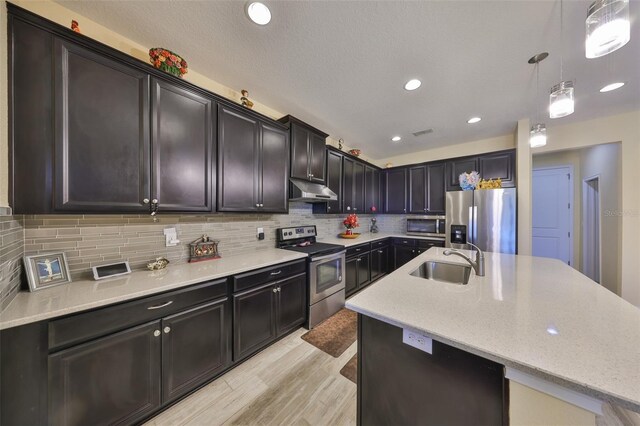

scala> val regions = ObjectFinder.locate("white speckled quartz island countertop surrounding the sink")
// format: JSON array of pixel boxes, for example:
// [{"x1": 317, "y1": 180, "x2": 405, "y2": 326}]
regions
[{"x1": 346, "y1": 247, "x2": 640, "y2": 412}]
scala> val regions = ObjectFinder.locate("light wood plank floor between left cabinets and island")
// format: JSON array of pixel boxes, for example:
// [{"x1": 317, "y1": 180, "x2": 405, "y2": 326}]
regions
[{"x1": 147, "y1": 329, "x2": 356, "y2": 426}]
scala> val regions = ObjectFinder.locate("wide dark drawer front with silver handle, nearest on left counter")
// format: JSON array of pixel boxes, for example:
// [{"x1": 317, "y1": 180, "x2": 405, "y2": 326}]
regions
[{"x1": 49, "y1": 279, "x2": 227, "y2": 349}]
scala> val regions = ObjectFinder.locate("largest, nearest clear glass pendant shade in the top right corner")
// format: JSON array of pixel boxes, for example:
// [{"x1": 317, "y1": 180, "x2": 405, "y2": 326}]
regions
[{"x1": 585, "y1": 0, "x2": 631, "y2": 58}]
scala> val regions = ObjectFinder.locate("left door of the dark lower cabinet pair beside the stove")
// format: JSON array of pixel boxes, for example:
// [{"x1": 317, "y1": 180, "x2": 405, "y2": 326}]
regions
[{"x1": 233, "y1": 284, "x2": 277, "y2": 361}]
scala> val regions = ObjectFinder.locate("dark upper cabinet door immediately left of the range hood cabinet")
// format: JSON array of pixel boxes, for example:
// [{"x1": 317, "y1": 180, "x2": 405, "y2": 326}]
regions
[{"x1": 259, "y1": 124, "x2": 289, "y2": 213}]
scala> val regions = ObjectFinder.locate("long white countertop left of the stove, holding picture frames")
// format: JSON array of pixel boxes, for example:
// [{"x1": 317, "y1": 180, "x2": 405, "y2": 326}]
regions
[{"x1": 0, "y1": 249, "x2": 307, "y2": 330}]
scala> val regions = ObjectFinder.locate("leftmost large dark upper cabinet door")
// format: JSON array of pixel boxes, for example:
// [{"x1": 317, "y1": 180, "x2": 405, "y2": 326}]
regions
[{"x1": 54, "y1": 39, "x2": 151, "y2": 212}]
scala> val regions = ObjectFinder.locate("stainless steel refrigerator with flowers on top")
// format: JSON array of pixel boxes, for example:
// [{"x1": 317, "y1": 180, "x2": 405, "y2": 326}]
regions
[{"x1": 446, "y1": 188, "x2": 517, "y2": 254}]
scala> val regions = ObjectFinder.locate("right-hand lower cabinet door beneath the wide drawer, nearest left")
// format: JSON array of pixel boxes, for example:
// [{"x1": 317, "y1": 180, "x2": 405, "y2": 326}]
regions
[{"x1": 162, "y1": 298, "x2": 231, "y2": 403}]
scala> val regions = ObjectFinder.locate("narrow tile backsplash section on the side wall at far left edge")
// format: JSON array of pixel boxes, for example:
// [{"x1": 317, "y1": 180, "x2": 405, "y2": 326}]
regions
[{"x1": 0, "y1": 216, "x2": 24, "y2": 310}]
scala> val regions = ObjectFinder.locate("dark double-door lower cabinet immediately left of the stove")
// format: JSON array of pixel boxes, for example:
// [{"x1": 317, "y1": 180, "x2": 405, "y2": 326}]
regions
[{"x1": 233, "y1": 273, "x2": 307, "y2": 361}]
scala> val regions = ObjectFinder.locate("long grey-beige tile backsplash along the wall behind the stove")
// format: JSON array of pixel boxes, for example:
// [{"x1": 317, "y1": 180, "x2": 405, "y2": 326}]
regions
[{"x1": 23, "y1": 202, "x2": 404, "y2": 278}]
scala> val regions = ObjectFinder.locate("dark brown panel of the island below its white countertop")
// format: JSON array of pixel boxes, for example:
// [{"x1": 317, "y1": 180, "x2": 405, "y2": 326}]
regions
[{"x1": 357, "y1": 315, "x2": 509, "y2": 425}]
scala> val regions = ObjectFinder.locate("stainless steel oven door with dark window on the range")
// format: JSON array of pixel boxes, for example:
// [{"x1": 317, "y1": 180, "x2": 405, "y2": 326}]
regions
[{"x1": 309, "y1": 251, "x2": 345, "y2": 305}]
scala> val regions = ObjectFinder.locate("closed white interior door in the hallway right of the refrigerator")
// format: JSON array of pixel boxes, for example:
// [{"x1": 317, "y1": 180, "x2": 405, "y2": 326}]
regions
[{"x1": 532, "y1": 167, "x2": 573, "y2": 265}]
